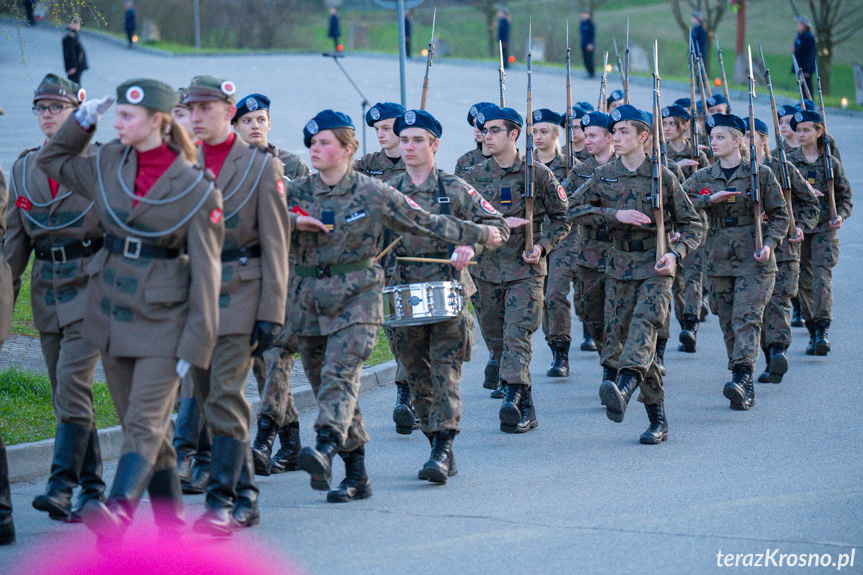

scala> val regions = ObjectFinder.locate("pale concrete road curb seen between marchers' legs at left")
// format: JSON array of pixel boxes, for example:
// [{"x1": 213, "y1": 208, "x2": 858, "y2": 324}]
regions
[{"x1": 6, "y1": 360, "x2": 396, "y2": 482}]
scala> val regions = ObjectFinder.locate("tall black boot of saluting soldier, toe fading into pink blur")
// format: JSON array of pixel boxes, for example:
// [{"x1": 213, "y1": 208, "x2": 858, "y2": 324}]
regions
[{"x1": 81, "y1": 453, "x2": 153, "y2": 551}]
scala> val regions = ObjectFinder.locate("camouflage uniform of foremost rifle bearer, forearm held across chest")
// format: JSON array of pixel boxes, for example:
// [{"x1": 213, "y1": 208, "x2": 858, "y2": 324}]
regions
[{"x1": 568, "y1": 158, "x2": 701, "y2": 405}]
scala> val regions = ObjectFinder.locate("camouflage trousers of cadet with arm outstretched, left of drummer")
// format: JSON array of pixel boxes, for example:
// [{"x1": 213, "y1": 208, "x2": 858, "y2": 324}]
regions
[{"x1": 298, "y1": 323, "x2": 380, "y2": 451}]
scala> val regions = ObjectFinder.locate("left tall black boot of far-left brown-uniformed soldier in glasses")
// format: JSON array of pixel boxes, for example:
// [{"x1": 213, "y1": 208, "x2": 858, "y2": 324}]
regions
[{"x1": 33, "y1": 423, "x2": 90, "y2": 521}]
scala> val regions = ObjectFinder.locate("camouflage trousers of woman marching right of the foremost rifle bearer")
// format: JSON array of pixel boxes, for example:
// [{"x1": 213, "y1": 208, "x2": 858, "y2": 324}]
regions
[{"x1": 710, "y1": 273, "x2": 776, "y2": 369}]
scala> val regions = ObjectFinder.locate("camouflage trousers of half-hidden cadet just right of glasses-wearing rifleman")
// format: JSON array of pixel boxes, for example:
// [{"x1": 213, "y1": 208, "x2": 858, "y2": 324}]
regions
[{"x1": 542, "y1": 246, "x2": 575, "y2": 344}]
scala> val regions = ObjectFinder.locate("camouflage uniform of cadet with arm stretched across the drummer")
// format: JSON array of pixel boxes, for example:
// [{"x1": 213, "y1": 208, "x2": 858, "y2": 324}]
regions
[{"x1": 287, "y1": 166, "x2": 488, "y2": 452}]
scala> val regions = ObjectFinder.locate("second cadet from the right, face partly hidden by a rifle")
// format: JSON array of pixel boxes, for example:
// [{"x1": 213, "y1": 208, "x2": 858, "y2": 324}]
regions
[{"x1": 743, "y1": 118, "x2": 820, "y2": 383}]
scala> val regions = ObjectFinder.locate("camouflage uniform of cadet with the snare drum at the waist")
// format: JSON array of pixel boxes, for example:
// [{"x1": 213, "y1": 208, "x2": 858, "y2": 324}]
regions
[{"x1": 389, "y1": 168, "x2": 509, "y2": 434}]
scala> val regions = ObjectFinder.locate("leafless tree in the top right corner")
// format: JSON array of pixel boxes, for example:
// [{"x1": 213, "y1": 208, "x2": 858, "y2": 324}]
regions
[{"x1": 788, "y1": 0, "x2": 863, "y2": 94}]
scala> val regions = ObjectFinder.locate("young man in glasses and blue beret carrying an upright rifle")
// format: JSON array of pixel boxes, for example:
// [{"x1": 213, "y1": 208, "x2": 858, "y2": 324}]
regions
[{"x1": 465, "y1": 105, "x2": 569, "y2": 433}]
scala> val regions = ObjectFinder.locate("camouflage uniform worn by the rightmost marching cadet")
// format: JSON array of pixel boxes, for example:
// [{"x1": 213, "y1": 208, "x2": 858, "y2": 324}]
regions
[{"x1": 788, "y1": 149, "x2": 852, "y2": 323}]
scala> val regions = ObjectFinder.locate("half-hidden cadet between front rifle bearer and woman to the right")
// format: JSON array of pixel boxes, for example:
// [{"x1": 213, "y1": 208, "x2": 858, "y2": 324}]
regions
[{"x1": 662, "y1": 104, "x2": 710, "y2": 353}]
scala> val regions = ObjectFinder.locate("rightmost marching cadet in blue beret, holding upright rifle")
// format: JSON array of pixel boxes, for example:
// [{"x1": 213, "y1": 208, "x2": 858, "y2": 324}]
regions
[{"x1": 788, "y1": 110, "x2": 852, "y2": 355}]
